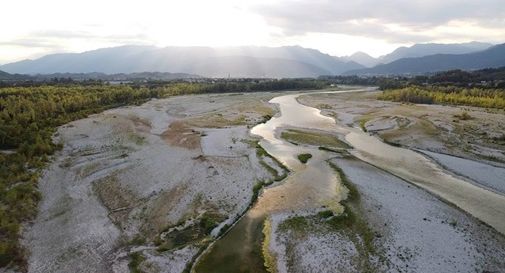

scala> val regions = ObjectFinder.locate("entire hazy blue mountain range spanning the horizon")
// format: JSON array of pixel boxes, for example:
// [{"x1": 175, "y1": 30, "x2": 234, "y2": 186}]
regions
[{"x1": 0, "y1": 42, "x2": 505, "y2": 77}]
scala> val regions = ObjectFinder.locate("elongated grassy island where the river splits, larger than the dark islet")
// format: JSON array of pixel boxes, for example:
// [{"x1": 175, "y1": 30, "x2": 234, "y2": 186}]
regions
[{"x1": 281, "y1": 129, "x2": 350, "y2": 149}]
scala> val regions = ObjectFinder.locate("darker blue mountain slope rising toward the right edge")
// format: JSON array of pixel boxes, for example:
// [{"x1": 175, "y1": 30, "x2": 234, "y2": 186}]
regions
[{"x1": 345, "y1": 44, "x2": 505, "y2": 75}]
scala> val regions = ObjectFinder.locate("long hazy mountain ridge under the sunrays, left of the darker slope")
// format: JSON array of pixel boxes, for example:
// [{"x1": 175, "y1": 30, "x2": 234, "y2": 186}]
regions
[{"x1": 0, "y1": 46, "x2": 363, "y2": 78}]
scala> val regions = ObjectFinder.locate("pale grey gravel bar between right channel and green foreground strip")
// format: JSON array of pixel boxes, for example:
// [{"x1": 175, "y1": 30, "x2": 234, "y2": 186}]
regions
[{"x1": 333, "y1": 156, "x2": 505, "y2": 272}]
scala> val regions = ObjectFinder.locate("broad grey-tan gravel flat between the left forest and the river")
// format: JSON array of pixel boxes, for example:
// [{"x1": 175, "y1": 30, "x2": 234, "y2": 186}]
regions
[{"x1": 23, "y1": 93, "x2": 286, "y2": 272}]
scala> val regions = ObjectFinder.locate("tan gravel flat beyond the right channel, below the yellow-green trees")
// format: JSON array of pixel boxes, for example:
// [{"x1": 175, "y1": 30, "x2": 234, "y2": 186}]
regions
[{"x1": 298, "y1": 92, "x2": 505, "y2": 166}]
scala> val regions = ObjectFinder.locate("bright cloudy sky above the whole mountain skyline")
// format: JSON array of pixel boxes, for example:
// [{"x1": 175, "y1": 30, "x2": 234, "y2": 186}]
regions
[{"x1": 0, "y1": 0, "x2": 505, "y2": 64}]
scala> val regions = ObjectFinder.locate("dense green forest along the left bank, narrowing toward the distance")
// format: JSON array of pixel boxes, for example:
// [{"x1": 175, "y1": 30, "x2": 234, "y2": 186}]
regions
[{"x1": 0, "y1": 80, "x2": 325, "y2": 267}]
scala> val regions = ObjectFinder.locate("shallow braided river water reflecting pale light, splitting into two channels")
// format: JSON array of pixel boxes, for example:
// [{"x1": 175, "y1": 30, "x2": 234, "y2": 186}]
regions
[{"x1": 195, "y1": 86, "x2": 505, "y2": 272}]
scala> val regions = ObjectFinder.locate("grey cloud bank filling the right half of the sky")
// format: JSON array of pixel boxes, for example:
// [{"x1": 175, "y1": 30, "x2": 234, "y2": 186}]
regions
[{"x1": 253, "y1": 0, "x2": 505, "y2": 43}]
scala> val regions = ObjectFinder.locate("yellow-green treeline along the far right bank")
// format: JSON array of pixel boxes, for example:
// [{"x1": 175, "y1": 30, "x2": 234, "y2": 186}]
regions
[{"x1": 379, "y1": 86, "x2": 505, "y2": 109}]
